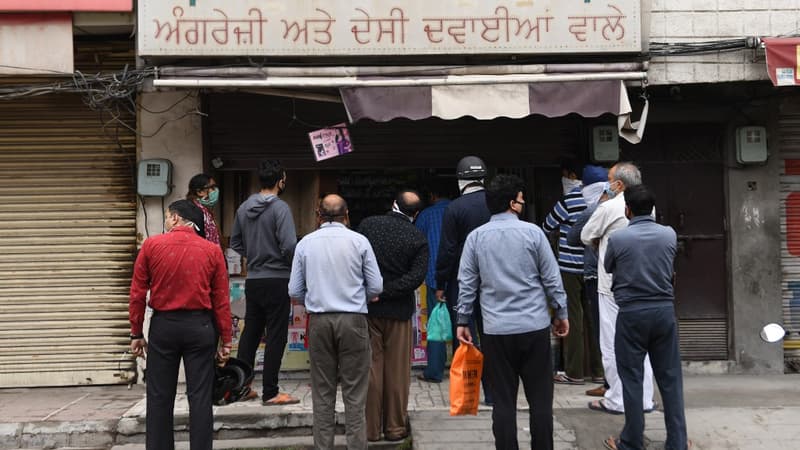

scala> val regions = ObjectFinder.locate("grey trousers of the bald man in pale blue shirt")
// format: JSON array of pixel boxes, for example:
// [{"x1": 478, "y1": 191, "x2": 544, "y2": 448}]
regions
[{"x1": 308, "y1": 313, "x2": 372, "y2": 450}]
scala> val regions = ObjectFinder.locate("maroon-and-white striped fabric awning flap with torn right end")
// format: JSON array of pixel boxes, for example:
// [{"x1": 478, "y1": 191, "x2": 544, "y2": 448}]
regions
[{"x1": 340, "y1": 80, "x2": 649, "y2": 144}]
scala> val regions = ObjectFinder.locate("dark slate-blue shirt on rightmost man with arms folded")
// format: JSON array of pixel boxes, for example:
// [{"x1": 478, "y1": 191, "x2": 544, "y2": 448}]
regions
[{"x1": 603, "y1": 216, "x2": 677, "y2": 311}]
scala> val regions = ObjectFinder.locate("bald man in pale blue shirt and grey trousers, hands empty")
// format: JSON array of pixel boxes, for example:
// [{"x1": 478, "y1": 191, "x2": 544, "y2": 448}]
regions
[{"x1": 289, "y1": 195, "x2": 383, "y2": 449}]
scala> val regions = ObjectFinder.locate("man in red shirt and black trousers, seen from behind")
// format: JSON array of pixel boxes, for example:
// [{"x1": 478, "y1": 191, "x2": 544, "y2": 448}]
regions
[{"x1": 129, "y1": 200, "x2": 231, "y2": 450}]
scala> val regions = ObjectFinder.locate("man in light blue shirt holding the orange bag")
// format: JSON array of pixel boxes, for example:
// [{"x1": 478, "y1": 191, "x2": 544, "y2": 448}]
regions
[{"x1": 456, "y1": 175, "x2": 569, "y2": 450}]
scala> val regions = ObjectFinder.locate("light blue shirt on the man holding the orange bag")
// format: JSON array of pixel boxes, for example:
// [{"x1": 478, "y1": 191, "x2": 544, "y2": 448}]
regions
[{"x1": 458, "y1": 212, "x2": 567, "y2": 335}]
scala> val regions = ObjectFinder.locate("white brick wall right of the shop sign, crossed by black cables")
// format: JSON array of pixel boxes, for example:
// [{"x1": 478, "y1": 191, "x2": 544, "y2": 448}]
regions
[{"x1": 649, "y1": 0, "x2": 800, "y2": 84}]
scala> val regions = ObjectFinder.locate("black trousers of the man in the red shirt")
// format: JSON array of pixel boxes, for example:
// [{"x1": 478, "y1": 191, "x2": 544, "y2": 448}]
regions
[{"x1": 146, "y1": 311, "x2": 217, "y2": 450}]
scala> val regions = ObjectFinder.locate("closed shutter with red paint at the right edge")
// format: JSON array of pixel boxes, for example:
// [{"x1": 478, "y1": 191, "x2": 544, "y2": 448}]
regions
[{"x1": 778, "y1": 105, "x2": 800, "y2": 368}]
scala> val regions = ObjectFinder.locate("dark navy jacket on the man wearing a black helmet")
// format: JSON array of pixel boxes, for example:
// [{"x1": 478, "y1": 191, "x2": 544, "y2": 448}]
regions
[{"x1": 436, "y1": 190, "x2": 492, "y2": 289}]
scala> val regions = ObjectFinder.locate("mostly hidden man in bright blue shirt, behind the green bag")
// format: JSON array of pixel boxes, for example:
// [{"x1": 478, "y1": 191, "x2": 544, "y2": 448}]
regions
[{"x1": 414, "y1": 183, "x2": 450, "y2": 383}]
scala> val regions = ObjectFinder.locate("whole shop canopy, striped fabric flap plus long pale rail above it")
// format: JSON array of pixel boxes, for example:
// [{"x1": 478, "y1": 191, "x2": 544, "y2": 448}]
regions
[{"x1": 154, "y1": 69, "x2": 649, "y2": 144}]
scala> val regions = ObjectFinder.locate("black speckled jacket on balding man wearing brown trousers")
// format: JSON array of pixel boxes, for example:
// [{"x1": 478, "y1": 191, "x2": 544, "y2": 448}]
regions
[{"x1": 358, "y1": 212, "x2": 428, "y2": 320}]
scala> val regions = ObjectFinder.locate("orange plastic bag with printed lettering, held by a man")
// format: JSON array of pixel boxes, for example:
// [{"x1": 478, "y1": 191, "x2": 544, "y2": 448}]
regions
[{"x1": 450, "y1": 344, "x2": 483, "y2": 416}]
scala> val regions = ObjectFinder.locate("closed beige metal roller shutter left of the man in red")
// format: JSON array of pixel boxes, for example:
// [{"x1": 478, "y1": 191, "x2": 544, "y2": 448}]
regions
[{"x1": 0, "y1": 95, "x2": 136, "y2": 387}]
